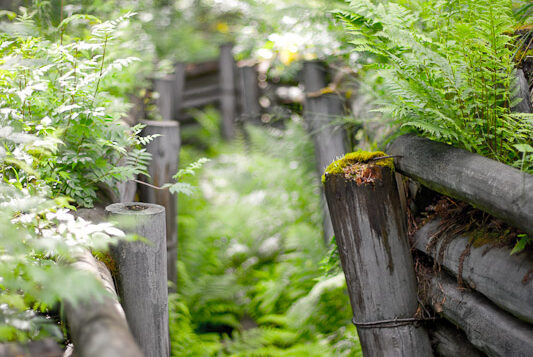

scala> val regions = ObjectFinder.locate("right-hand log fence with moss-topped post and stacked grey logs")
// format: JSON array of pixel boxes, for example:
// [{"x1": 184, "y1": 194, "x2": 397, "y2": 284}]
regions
[{"x1": 325, "y1": 135, "x2": 533, "y2": 356}]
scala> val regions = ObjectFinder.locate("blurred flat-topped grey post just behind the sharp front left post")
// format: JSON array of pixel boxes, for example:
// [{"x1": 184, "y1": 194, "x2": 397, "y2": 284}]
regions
[{"x1": 139, "y1": 120, "x2": 180, "y2": 291}]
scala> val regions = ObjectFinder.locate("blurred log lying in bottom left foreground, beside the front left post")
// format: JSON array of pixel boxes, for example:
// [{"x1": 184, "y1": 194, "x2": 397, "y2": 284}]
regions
[{"x1": 63, "y1": 251, "x2": 143, "y2": 357}]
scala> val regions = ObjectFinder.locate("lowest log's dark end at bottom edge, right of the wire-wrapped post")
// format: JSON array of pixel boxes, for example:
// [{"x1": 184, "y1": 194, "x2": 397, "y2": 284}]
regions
[{"x1": 429, "y1": 321, "x2": 485, "y2": 357}]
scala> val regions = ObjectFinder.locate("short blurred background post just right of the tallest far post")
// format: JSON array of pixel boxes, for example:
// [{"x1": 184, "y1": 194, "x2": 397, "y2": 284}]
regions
[{"x1": 239, "y1": 66, "x2": 261, "y2": 124}]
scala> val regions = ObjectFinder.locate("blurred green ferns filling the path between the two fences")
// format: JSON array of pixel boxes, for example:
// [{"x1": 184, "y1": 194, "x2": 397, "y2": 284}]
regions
[{"x1": 170, "y1": 115, "x2": 361, "y2": 356}]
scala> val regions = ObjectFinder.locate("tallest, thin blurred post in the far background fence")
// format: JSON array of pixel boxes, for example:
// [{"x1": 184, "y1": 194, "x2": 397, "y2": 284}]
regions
[{"x1": 219, "y1": 44, "x2": 237, "y2": 140}]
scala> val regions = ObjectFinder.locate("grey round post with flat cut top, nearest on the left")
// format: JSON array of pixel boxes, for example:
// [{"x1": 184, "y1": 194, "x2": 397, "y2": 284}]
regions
[{"x1": 106, "y1": 202, "x2": 170, "y2": 357}]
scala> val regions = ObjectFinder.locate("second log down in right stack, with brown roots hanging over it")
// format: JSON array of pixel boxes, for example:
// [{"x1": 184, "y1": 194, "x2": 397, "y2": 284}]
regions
[{"x1": 415, "y1": 220, "x2": 533, "y2": 324}]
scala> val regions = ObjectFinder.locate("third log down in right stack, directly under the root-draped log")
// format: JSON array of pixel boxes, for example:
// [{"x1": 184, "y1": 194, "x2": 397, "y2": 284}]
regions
[{"x1": 428, "y1": 274, "x2": 533, "y2": 357}]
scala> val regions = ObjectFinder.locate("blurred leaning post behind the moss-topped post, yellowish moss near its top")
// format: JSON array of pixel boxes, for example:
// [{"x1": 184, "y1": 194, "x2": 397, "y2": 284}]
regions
[{"x1": 303, "y1": 61, "x2": 347, "y2": 243}]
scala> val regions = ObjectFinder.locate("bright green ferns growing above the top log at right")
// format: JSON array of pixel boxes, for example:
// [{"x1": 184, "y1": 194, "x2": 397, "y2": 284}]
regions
[{"x1": 337, "y1": 0, "x2": 533, "y2": 172}]
